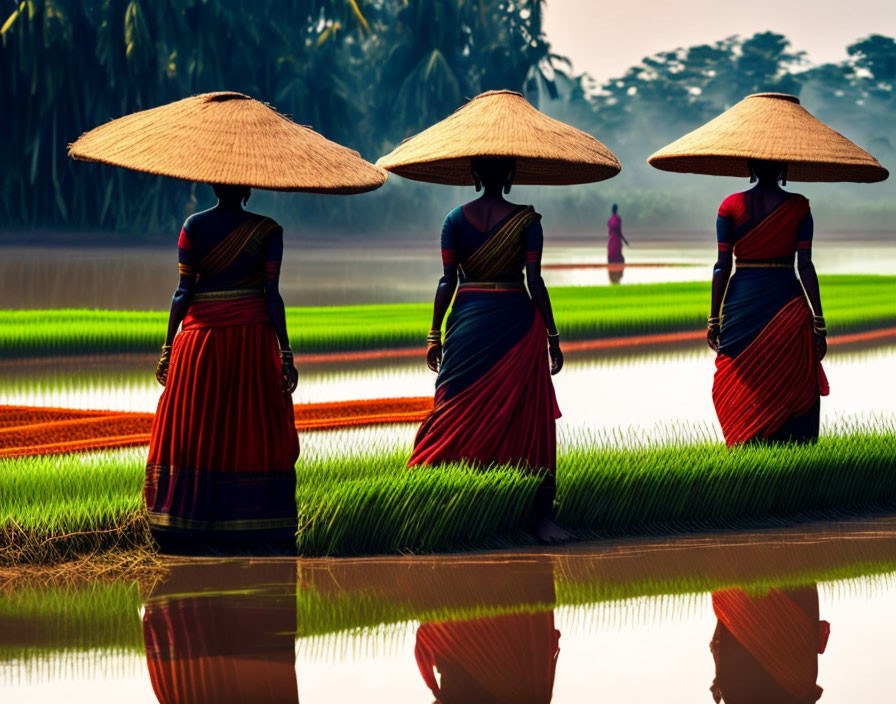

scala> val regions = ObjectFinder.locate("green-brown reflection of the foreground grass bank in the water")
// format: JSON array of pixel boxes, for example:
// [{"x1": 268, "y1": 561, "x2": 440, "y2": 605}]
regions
[{"x1": 0, "y1": 540, "x2": 896, "y2": 681}]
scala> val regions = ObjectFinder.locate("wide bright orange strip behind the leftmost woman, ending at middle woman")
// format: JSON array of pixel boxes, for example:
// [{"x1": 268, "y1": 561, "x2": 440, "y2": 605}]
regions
[{"x1": 0, "y1": 396, "x2": 432, "y2": 458}]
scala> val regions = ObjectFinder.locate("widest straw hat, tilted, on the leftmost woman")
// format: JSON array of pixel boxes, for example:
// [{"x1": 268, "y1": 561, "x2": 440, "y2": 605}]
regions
[{"x1": 69, "y1": 93, "x2": 386, "y2": 193}]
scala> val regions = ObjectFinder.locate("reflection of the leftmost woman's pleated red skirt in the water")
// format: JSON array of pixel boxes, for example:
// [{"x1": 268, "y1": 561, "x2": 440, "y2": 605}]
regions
[{"x1": 143, "y1": 561, "x2": 299, "y2": 704}]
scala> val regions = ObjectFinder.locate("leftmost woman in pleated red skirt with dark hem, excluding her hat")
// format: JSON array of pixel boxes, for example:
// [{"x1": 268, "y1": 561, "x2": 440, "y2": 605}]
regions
[{"x1": 144, "y1": 186, "x2": 299, "y2": 552}]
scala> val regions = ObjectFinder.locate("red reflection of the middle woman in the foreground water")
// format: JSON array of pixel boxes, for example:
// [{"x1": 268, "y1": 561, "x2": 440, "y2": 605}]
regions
[{"x1": 414, "y1": 562, "x2": 560, "y2": 704}]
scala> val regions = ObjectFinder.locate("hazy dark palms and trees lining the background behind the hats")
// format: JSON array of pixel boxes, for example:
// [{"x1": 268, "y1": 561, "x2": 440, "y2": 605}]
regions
[{"x1": 0, "y1": 0, "x2": 896, "y2": 234}]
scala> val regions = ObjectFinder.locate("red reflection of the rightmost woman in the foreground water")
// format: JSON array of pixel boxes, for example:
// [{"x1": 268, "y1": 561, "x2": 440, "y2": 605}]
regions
[{"x1": 710, "y1": 586, "x2": 831, "y2": 704}]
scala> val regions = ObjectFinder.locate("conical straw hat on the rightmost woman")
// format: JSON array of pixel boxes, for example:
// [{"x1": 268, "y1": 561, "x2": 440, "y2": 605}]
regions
[{"x1": 647, "y1": 93, "x2": 889, "y2": 183}]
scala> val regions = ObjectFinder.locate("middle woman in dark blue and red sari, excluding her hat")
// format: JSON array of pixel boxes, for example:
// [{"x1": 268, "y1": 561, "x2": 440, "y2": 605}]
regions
[{"x1": 409, "y1": 158, "x2": 566, "y2": 542}]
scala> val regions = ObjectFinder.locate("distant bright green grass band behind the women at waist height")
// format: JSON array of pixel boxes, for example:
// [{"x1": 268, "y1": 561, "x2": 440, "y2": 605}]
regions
[{"x1": 0, "y1": 275, "x2": 896, "y2": 357}]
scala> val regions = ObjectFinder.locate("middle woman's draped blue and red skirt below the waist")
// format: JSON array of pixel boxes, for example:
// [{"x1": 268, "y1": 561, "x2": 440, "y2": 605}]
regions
[{"x1": 408, "y1": 290, "x2": 560, "y2": 516}]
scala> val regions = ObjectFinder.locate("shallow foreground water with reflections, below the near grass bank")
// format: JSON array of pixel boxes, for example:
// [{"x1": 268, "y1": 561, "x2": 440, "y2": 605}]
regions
[{"x1": 0, "y1": 518, "x2": 896, "y2": 704}]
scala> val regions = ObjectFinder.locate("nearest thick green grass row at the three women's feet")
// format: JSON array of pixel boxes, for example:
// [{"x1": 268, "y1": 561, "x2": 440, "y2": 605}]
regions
[{"x1": 0, "y1": 427, "x2": 896, "y2": 563}]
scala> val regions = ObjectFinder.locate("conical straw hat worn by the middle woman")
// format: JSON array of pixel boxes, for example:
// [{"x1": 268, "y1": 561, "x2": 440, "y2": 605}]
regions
[{"x1": 377, "y1": 90, "x2": 620, "y2": 186}]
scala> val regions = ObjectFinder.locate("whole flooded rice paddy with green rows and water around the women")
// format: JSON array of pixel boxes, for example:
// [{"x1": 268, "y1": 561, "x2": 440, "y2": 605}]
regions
[{"x1": 0, "y1": 242, "x2": 896, "y2": 704}]
